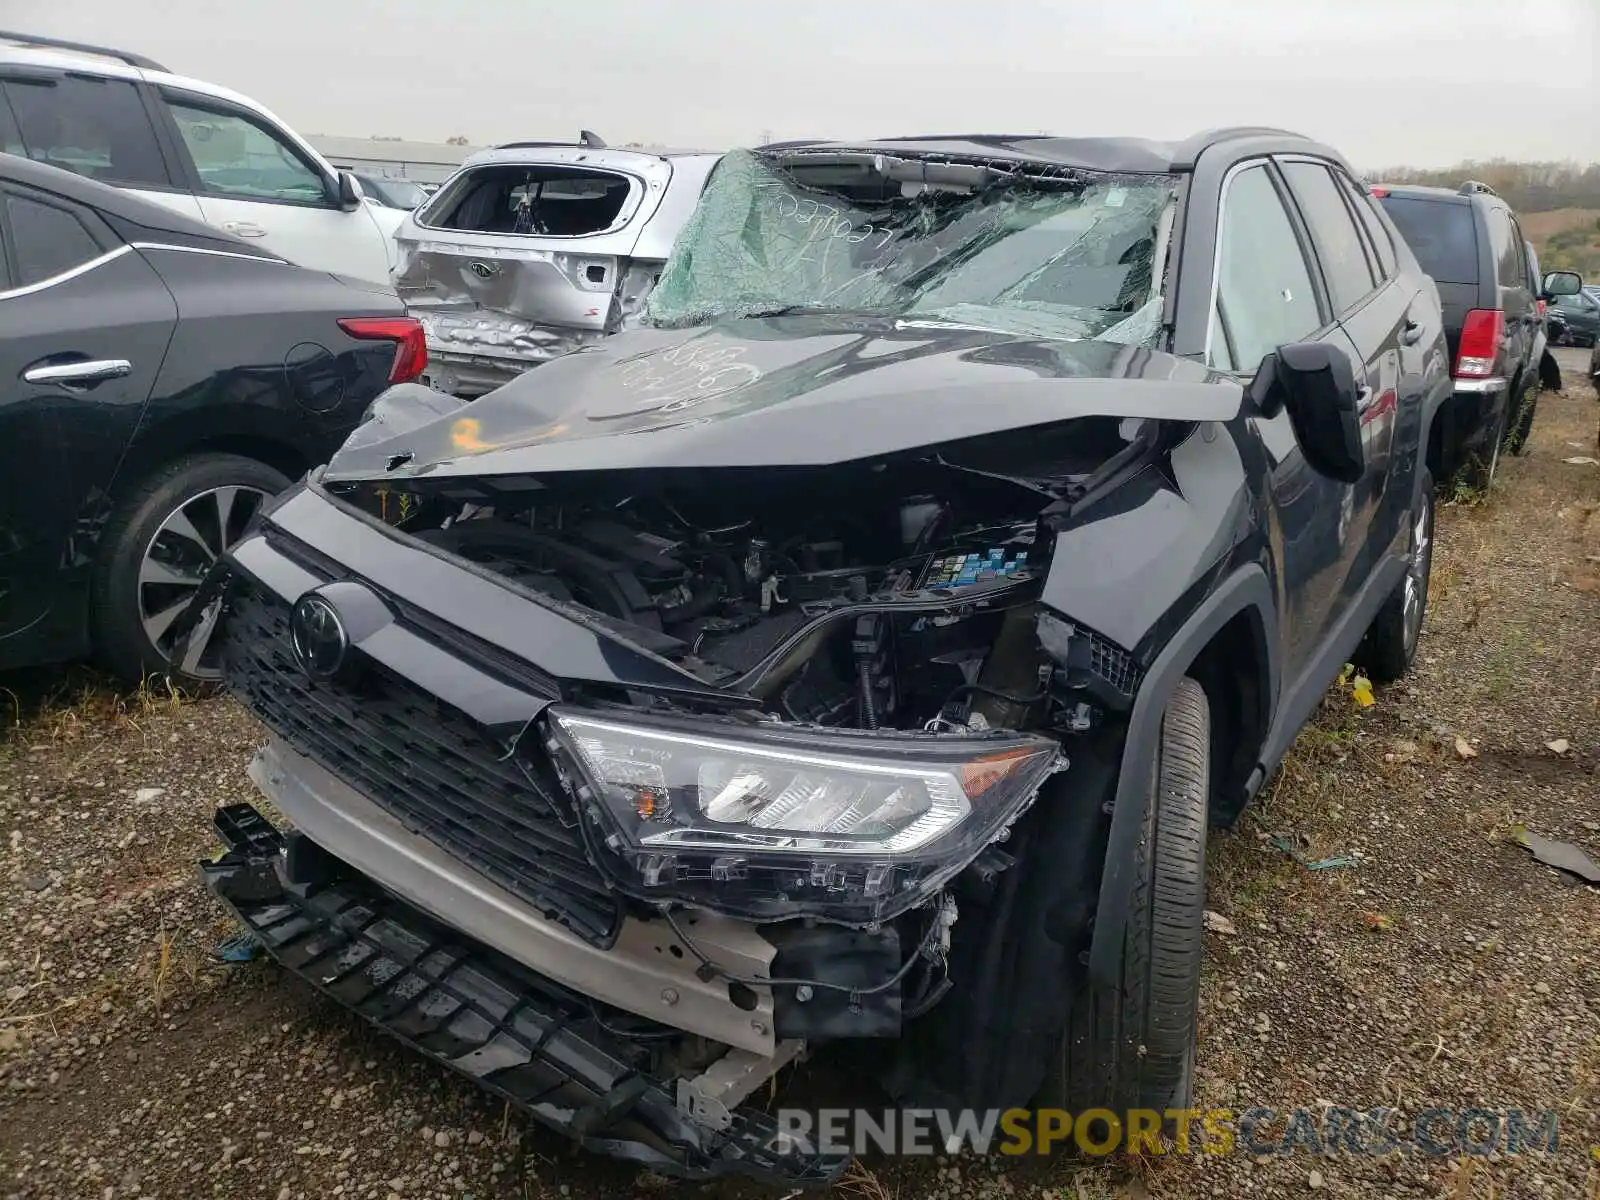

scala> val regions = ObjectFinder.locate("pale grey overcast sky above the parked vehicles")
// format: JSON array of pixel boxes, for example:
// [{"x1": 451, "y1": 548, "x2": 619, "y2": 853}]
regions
[{"x1": 12, "y1": 0, "x2": 1600, "y2": 168}]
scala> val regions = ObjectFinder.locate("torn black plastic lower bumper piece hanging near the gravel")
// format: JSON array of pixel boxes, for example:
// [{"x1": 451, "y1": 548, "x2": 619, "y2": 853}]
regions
[{"x1": 200, "y1": 805, "x2": 848, "y2": 1187}]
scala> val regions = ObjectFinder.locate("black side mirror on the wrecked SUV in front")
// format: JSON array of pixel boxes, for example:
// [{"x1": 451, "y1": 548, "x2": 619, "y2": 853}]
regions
[{"x1": 1250, "y1": 342, "x2": 1366, "y2": 483}]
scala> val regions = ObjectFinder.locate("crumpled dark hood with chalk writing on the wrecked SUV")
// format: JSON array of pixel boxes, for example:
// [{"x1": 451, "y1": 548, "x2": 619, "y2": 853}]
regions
[{"x1": 325, "y1": 314, "x2": 1243, "y2": 482}]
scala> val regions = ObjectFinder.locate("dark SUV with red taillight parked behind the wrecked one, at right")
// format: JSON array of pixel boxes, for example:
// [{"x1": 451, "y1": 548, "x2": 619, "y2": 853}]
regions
[{"x1": 1373, "y1": 181, "x2": 1552, "y2": 488}]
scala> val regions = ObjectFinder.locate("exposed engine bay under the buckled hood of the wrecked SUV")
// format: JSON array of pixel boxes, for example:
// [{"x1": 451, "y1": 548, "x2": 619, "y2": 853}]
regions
[{"x1": 333, "y1": 419, "x2": 1157, "y2": 733}]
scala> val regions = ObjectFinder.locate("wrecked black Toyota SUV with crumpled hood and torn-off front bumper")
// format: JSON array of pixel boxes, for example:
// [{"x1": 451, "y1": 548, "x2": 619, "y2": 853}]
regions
[{"x1": 196, "y1": 130, "x2": 1451, "y2": 1182}]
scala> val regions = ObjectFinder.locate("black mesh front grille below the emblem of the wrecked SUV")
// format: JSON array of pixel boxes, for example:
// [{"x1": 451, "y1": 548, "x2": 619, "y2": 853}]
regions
[{"x1": 222, "y1": 584, "x2": 621, "y2": 946}]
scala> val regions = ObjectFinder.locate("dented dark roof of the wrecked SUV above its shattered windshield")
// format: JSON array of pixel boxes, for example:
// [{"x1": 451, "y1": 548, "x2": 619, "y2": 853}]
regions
[{"x1": 758, "y1": 125, "x2": 1324, "y2": 174}]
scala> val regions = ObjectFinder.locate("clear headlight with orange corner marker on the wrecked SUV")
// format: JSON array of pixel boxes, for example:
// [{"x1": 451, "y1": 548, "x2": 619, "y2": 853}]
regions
[{"x1": 552, "y1": 710, "x2": 1059, "y2": 858}]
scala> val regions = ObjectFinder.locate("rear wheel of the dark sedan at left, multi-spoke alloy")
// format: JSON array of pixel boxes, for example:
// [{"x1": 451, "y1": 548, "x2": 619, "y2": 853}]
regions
[{"x1": 93, "y1": 454, "x2": 290, "y2": 691}]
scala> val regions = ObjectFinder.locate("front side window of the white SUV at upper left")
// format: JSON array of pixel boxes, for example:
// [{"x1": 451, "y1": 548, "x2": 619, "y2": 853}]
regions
[{"x1": 168, "y1": 98, "x2": 328, "y2": 205}]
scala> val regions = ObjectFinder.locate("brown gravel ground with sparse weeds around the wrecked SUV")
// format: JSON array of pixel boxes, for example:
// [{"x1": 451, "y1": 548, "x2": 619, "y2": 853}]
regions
[{"x1": 0, "y1": 352, "x2": 1600, "y2": 1200}]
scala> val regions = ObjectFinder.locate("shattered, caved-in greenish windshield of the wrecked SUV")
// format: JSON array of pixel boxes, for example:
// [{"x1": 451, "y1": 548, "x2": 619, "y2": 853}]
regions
[{"x1": 646, "y1": 150, "x2": 1176, "y2": 344}]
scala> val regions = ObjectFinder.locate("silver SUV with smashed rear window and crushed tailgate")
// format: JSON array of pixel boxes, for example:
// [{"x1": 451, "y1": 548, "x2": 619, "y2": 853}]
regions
[{"x1": 395, "y1": 131, "x2": 720, "y2": 397}]
